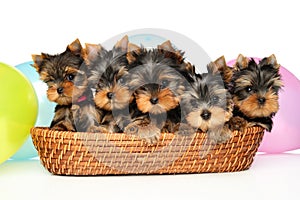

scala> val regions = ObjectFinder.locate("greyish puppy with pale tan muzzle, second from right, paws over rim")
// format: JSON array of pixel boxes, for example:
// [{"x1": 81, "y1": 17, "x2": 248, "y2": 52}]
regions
[{"x1": 178, "y1": 57, "x2": 233, "y2": 143}]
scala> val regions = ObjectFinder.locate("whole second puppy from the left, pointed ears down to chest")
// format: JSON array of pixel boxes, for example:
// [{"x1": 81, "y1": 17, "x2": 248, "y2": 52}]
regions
[{"x1": 86, "y1": 36, "x2": 134, "y2": 132}]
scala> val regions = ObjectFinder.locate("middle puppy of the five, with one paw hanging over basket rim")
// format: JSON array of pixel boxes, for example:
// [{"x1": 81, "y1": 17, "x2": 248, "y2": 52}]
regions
[{"x1": 124, "y1": 41, "x2": 194, "y2": 144}]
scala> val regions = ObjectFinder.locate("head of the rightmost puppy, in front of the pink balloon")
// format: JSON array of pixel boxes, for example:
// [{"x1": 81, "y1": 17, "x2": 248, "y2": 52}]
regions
[{"x1": 233, "y1": 55, "x2": 282, "y2": 118}]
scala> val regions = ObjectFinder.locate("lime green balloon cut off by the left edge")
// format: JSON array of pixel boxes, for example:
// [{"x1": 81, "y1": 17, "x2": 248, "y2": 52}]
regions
[{"x1": 0, "y1": 63, "x2": 38, "y2": 164}]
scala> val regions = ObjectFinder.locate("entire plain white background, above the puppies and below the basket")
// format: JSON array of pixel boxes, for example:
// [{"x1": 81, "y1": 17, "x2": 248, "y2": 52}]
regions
[{"x1": 0, "y1": 0, "x2": 300, "y2": 200}]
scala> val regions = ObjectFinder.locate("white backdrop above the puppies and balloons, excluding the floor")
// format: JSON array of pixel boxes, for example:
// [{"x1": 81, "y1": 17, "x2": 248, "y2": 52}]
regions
[{"x1": 0, "y1": 0, "x2": 300, "y2": 78}]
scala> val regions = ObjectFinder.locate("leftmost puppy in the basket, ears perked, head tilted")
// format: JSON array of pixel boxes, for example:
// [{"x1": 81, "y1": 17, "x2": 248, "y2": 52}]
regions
[{"x1": 32, "y1": 39, "x2": 87, "y2": 131}]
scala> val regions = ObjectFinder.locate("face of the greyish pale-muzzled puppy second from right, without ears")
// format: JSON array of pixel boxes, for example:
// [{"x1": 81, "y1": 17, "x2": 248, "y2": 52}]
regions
[{"x1": 184, "y1": 73, "x2": 233, "y2": 132}]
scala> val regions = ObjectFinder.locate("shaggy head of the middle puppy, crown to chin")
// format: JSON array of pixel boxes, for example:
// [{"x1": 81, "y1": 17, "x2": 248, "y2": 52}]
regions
[{"x1": 128, "y1": 48, "x2": 190, "y2": 114}]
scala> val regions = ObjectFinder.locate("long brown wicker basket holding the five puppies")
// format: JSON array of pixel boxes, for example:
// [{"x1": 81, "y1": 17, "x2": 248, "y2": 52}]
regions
[{"x1": 31, "y1": 127, "x2": 264, "y2": 175}]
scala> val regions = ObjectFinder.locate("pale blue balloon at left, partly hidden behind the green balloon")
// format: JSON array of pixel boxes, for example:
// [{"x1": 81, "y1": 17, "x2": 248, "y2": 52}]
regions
[{"x1": 11, "y1": 62, "x2": 56, "y2": 160}]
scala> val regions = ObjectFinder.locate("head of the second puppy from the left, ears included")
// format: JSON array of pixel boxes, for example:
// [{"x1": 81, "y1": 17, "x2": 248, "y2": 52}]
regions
[{"x1": 86, "y1": 36, "x2": 132, "y2": 111}]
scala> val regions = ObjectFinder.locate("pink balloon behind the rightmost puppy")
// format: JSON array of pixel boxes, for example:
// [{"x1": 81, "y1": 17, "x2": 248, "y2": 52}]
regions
[{"x1": 227, "y1": 58, "x2": 300, "y2": 153}]
